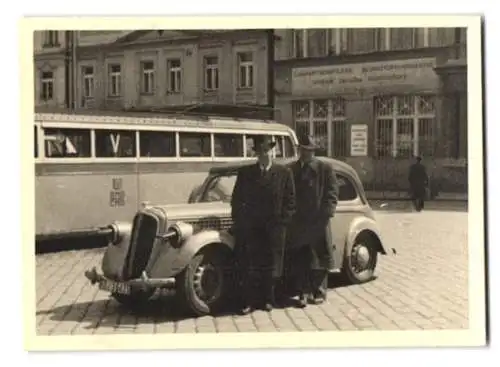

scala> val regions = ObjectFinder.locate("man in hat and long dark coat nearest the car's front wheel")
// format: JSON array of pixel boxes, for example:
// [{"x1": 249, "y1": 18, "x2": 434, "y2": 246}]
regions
[{"x1": 231, "y1": 136, "x2": 295, "y2": 314}]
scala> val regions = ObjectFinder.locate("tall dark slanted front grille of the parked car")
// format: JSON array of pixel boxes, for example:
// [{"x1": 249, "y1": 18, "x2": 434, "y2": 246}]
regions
[{"x1": 125, "y1": 213, "x2": 158, "y2": 279}]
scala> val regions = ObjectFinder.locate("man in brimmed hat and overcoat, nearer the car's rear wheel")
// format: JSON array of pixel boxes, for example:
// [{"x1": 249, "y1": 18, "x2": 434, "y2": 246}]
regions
[{"x1": 287, "y1": 136, "x2": 338, "y2": 307}]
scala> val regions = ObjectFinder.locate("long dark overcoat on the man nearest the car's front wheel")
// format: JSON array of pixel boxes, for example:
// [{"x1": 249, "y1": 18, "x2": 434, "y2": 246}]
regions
[{"x1": 231, "y1": 163, "x2": 296, "y2": 277}]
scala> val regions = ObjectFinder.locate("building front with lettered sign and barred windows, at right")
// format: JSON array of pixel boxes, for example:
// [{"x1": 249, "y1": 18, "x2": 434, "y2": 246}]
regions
[{"x1": 275, "y1": 28, "x2": 467, "y2": 190}]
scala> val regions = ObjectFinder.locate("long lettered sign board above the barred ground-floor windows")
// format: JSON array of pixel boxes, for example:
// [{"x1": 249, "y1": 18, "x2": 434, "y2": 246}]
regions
[{"x1": 292, "y1": 58, "x2": 439, "y2": 95}]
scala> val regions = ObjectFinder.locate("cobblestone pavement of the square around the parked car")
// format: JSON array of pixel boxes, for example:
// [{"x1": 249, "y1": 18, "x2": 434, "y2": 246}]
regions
[{"x1": 36, "y1": 210, "x2": 468, "y2": 335}]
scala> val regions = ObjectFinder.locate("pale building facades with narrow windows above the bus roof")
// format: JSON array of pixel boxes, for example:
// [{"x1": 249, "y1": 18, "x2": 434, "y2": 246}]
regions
[{"x1": 35, "y1": 30, "x2": 269, "y2": 109}]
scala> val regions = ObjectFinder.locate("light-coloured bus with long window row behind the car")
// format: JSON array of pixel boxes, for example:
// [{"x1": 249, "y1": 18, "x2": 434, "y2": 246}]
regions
[{"x1": 34, "y1": 106, "x2": 297, "y2": 247}]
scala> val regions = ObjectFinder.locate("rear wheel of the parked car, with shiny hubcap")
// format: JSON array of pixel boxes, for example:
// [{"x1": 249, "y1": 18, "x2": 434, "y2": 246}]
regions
[{"x1": 342, "y1": 234, "x2": 378, "y2": 284}]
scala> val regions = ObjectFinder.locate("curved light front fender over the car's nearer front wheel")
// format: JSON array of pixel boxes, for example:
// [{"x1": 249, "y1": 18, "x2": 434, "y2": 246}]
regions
[{"x1": 147, "y1": 230, "x2": 234, "y2": 278}]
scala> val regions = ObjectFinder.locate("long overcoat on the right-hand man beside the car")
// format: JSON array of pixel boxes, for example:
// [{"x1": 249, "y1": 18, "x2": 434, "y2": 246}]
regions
[{"x1": 287, "y1": 158, "x2": 338, "y2": 269}]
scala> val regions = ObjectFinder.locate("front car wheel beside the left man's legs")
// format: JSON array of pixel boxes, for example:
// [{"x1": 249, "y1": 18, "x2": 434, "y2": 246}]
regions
[{"x1": 176, "y1": 247, "x2": 232, "y2": 316}]
